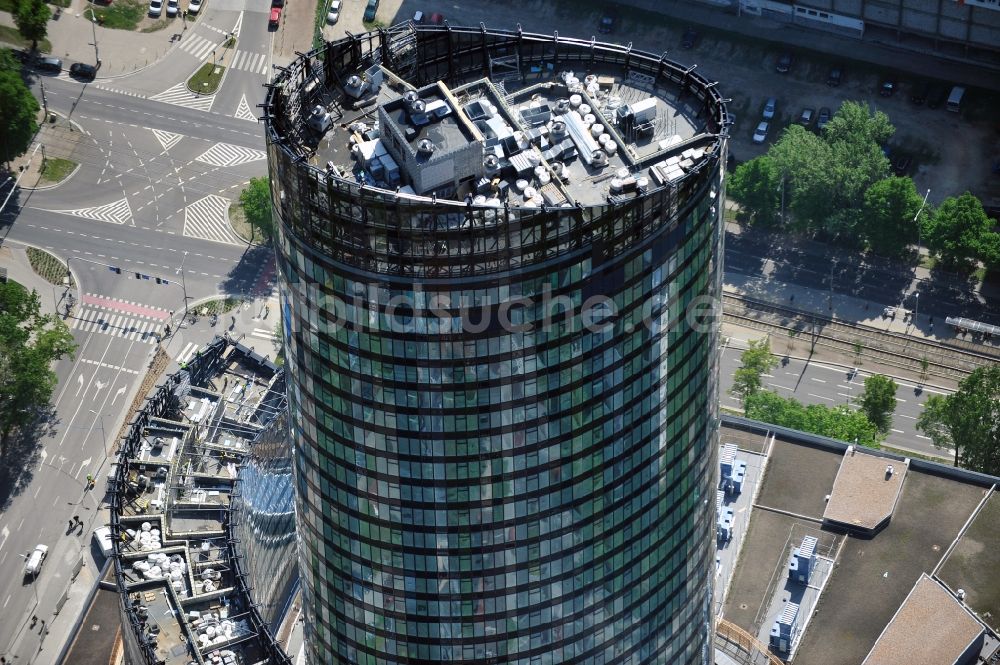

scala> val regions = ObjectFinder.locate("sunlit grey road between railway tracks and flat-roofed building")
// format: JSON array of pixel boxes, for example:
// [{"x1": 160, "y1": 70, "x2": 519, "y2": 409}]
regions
[{"x1": 719, "y1": 345, "x2": 954, "y2": 456}]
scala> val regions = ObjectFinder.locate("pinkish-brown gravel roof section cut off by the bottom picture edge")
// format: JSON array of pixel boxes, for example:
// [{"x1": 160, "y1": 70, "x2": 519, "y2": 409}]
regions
[{"x1": 863, "y1": 573, "x2": 983, "y2": 665}]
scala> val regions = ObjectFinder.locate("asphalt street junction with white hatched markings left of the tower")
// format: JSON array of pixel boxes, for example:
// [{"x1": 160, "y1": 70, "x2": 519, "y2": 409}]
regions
[{"x1": 0, "y1": 9, "x2": 273, "y2": 662}]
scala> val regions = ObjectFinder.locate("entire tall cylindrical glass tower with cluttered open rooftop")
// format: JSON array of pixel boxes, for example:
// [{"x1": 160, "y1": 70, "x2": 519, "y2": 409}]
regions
[{"x1": 265, "y1": 24, "x2": 726, "y2": 665}]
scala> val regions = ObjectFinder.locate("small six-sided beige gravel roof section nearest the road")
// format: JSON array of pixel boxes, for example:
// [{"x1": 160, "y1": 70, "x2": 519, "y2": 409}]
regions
[{"x1": 823, "y1": 446, "x2": 907, "y2": 531}]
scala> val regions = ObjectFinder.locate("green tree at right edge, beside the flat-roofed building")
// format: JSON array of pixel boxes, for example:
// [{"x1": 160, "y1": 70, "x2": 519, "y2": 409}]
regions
[{"x1": 917, "y1": 364, "x2": 1000, "y2": 475}]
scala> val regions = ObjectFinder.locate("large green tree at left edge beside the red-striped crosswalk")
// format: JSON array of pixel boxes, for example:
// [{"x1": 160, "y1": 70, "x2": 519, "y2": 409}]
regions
[{"x1": 0, "y1": 282, "x2": 76, "y2": 455}]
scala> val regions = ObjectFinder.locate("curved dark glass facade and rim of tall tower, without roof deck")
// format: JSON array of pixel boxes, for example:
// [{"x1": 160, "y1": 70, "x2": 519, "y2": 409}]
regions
[{"x1": 266, "y1": 23, "x2": 725, "y2": 665}]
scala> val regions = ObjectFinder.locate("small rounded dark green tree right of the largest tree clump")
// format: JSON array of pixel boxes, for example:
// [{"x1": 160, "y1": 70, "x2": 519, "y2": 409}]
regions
[{"x1": 861, "y1": 176, "x2": 923, "y2": 256}]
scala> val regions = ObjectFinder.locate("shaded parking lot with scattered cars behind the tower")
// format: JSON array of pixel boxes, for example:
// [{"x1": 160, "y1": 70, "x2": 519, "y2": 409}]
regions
[{"x1": 325, "y1": 0, "x2": 1000, "y2": 206}]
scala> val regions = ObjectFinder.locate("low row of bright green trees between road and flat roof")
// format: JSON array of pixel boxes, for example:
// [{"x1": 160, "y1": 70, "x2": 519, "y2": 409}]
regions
[{"x1": 743, "y1": 390, "x2": 884, "y2": 448}]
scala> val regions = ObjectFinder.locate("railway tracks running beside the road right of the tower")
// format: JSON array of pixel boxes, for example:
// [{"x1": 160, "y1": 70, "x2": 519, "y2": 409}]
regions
[{"x1": 723, "y1": 293, "x2": 1000, "y2": 380}]
